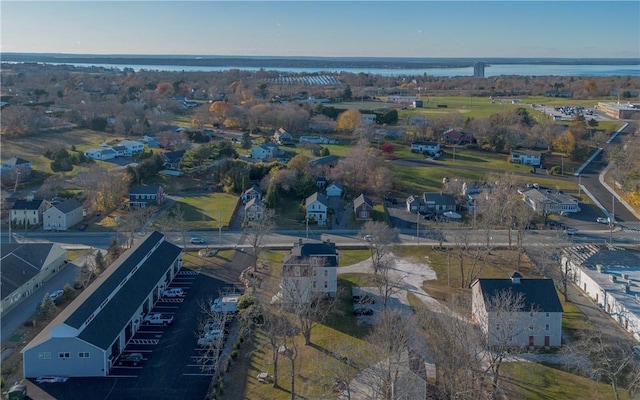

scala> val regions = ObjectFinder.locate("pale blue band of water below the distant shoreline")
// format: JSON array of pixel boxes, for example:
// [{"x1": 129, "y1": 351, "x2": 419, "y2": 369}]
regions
[{"x1": 11, "y1": 63, "x2": 640, "y2": 78}]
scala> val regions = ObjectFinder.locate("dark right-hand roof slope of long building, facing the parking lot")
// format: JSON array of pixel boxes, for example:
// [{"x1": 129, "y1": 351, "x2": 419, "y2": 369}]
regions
[{"x1": 78, "y1": 242, "x2": 182, "y2": 350}]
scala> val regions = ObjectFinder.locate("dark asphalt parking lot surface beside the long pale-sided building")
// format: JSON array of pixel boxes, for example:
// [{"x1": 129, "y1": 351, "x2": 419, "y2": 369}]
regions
[{"x1": 39, "y1": 268, "x2": 230, "y2": 400}]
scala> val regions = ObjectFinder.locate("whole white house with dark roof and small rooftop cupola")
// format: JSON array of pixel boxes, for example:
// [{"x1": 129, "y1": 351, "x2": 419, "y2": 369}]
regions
[{"x1": 471, "y1": 271, "x2": 563, "y2": 347}]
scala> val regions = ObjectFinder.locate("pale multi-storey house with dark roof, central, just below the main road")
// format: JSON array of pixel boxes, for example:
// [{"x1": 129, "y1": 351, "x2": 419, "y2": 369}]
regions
[{"x1": 279, "y1": 239, "x2": 339, "y2": 302}]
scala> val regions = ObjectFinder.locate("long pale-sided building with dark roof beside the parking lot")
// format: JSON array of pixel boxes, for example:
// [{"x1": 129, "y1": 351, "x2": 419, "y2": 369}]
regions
[{"x1": 22, "y1": 232, "x2": 182, "y2": 378}]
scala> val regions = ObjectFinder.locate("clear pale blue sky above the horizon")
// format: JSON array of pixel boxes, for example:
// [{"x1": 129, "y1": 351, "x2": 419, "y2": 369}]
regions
[{"x1": 0, "y1": 0, "x2": 640, "y2": 58}]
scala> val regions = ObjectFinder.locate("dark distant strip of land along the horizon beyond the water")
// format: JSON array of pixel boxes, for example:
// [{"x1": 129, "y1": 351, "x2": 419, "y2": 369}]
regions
[{"x1": 0, "y1": 53, "x2": 640, "y2": 69}]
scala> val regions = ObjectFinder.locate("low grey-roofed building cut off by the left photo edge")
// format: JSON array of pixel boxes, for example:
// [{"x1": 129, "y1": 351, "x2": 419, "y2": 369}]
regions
[{"x1": 0, "y1": 243, "x2": 67, "y2": 315}]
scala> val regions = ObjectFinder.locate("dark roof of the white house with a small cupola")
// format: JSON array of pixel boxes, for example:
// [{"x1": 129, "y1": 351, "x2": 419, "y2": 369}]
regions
[{"x1": 478, "y1": 278, "x2": 563, "y2": 312}]
